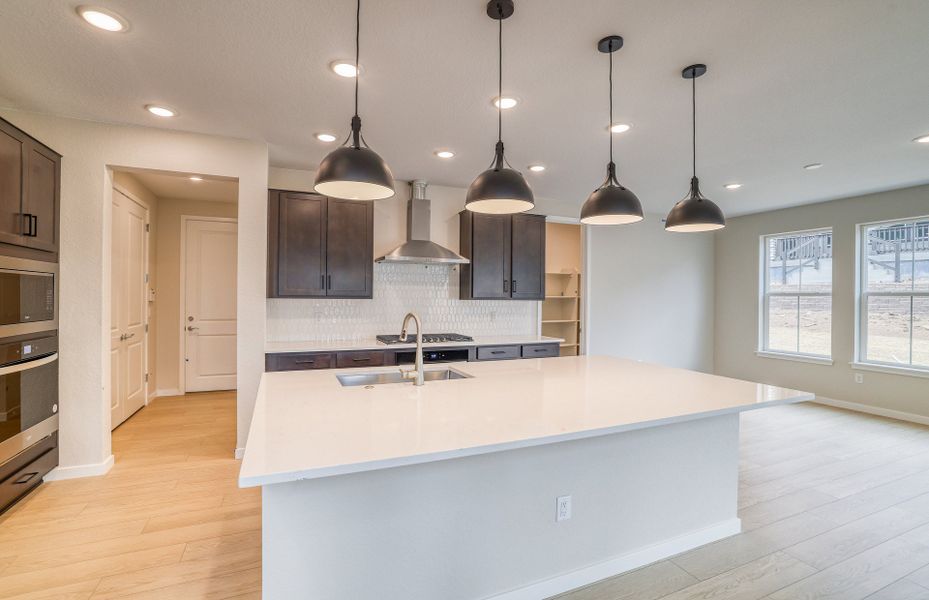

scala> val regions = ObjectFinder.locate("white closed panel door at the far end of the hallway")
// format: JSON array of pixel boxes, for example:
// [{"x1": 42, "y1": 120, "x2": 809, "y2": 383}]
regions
[{"x1": 182, "y1": 218, "x2": 238, "y2": 392}]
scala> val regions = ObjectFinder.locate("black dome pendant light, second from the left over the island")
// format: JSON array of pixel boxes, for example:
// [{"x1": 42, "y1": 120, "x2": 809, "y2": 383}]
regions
[{"x1": 465, "y1": 0, "x2": 535, "y2": 215}]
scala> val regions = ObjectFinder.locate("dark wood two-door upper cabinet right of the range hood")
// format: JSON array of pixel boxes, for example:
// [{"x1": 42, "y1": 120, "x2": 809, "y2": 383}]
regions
[{"x1": 460, "y1": 210, "x2": 545, "y2": 300}]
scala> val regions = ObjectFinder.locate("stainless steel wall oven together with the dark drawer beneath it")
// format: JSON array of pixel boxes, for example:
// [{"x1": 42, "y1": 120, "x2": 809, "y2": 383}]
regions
[{"x1": 0, "y1": 331, "x2": 58, "y2": 512}]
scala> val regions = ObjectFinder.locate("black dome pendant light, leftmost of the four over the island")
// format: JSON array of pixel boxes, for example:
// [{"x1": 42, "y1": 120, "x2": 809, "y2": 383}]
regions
[{"x1": 313, "y1": 0, "x2": 394, "y2": 200}]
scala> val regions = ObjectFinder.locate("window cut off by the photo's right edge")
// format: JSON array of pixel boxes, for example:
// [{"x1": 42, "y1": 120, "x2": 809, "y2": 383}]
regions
[{"x1": 858, "y1": 217, "x2": 929, "y2": 371}]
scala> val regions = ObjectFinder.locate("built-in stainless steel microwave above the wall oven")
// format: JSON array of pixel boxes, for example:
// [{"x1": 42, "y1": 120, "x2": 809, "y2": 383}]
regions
[{"x1": 0, "y1": 256, "x2": 58, "y2": 339}]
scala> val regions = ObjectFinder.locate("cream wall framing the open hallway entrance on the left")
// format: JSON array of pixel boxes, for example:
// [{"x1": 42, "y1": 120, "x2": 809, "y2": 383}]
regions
[{"x1": 0, "y1": 109, "x2": 268, "y2": 476}]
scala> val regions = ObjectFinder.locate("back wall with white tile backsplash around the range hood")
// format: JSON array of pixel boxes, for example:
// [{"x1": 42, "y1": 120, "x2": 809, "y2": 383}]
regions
[{"x1": 267, "y1": 167, "x2": 539, "y2": 342}]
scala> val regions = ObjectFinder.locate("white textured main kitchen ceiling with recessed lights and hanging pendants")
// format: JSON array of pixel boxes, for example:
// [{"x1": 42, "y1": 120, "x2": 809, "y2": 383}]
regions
[{"x1": 0, "y1": 0, "x2": 929, "y2": 215}]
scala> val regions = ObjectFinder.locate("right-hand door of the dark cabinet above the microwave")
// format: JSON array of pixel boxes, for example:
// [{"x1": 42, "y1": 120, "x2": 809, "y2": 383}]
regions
[{"x1": 23, "y1": 143, "x2": 61, "y2": 252}]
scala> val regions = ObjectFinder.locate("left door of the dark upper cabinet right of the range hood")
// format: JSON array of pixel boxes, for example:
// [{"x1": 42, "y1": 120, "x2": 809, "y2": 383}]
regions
[{"x1": 470, "y1": 213, "x2": 510, "y2": 299}]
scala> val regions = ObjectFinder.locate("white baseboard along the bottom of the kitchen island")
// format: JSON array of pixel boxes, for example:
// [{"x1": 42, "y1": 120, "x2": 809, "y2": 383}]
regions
[{"x1": 488, "y1": 518, "x2": 742, "y2": 600}]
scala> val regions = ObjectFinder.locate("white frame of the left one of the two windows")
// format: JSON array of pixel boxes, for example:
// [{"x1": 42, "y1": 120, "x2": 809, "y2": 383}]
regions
[{"x1": 755, "y1": 227, "x2": 835, "y2": 365}]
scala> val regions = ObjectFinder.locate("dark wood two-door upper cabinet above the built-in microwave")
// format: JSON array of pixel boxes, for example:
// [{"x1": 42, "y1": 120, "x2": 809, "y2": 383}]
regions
[{"x1": 0, "y1": 119, "x2": 61, "y2": 261}]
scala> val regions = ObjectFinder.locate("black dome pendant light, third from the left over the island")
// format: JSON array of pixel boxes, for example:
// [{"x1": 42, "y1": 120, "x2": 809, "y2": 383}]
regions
[{"x1": 581, "y1": 35, "x2": 642, "y2": 225}]
